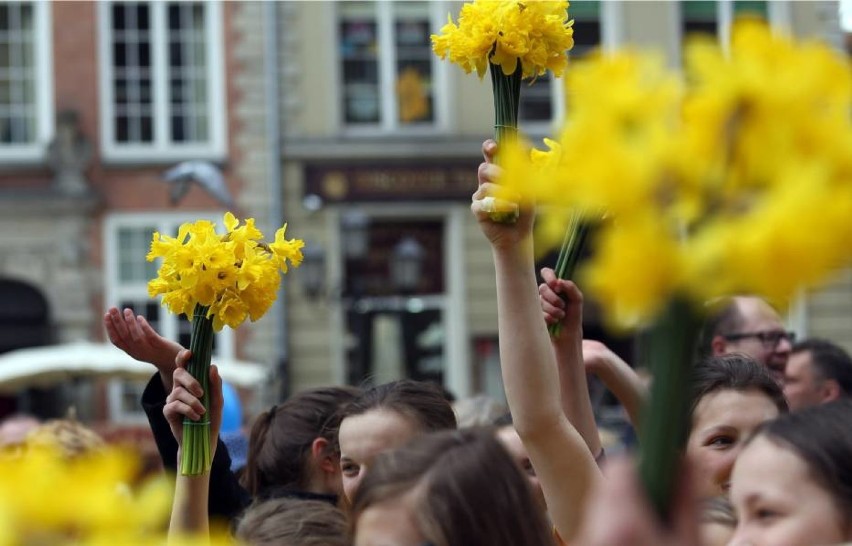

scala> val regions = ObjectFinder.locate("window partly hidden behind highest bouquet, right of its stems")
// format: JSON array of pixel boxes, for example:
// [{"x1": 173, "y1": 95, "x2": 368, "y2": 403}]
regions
[{"x1": 518, "y1": 0, "x2": 601, "y2": 125}]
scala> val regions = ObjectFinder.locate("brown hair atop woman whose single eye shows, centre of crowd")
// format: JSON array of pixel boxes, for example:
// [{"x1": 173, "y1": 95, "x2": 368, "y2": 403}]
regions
[{"x1": 328, "y1": 379, "x2": 456, "y2": 447}]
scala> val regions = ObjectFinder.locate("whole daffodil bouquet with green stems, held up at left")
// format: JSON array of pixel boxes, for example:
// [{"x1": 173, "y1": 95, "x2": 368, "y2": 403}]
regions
[{"x1": 147, "y1": 212, "x2": 304, "y2": 475}]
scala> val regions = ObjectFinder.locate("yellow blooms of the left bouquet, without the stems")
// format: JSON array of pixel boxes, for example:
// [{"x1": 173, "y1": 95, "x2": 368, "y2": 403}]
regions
[{"x1": 147, "y1": 212, "x2": 304, "y2": 331}]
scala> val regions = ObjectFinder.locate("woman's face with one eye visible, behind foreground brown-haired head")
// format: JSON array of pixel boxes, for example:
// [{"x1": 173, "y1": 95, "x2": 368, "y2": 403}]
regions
[{"x1": 338, "y1": 409, "x2": 419, "y2": 502}]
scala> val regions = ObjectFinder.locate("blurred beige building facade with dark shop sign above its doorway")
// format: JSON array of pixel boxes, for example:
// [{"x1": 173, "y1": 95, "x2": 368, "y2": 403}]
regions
[{"x1": 278, "y1": 0, "x2": 852, "y2": 398}]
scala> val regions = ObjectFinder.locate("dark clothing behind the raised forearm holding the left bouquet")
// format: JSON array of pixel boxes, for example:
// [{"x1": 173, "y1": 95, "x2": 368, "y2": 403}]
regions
[{"x1": 142, "y1": 374, "x2": 252, "y2": 521}]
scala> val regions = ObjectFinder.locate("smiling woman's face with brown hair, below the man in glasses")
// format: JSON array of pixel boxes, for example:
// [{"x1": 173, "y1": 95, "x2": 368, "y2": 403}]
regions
[{"x1": 686, "y1": 389, "x2": 778, "y2": 498}]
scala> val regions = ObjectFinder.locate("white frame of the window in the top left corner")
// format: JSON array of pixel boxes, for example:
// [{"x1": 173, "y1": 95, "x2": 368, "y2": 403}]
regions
[{"x1": 0, "y1": 0, "x2": 56, "y2": 164}]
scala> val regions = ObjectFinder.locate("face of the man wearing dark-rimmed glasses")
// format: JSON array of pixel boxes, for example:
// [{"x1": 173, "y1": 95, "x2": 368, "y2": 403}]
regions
[{"x1": 724, "y1": 297, "x2": 793, "y2": 384}]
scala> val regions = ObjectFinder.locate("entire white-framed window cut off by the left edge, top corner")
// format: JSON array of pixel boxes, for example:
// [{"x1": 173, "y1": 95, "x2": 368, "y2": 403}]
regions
[{"x1": 0, "y1": 2, "x2": 53, "y2": 161}]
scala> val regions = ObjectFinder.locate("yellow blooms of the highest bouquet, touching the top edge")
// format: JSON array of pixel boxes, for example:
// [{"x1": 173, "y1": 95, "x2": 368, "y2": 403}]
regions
[{"x1": 432, "y1": 0, "x2": 574, "y2": 78}]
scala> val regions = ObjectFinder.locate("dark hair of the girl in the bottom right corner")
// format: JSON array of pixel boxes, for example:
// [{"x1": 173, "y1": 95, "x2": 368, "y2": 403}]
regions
[{"x1": 746, "y1": 398, "x2": 852, "y2": 525}]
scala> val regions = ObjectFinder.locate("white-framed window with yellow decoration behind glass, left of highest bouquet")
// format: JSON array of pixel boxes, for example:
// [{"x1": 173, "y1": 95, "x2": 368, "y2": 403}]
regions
[{"x1": 338, "y1": 1, "x2": 446, "y2": 132}]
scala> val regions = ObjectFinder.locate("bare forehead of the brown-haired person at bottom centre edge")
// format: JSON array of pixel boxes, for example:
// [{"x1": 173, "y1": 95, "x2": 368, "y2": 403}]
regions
[{"x1": 354, "y1": 492, "x2": 426, "y2": 546}]
